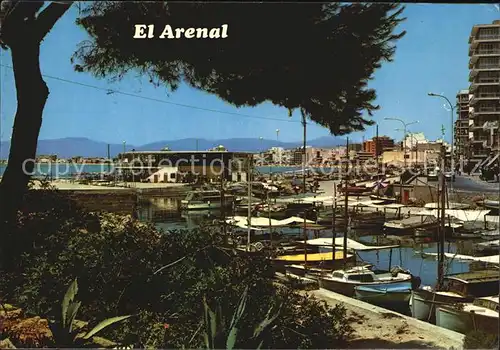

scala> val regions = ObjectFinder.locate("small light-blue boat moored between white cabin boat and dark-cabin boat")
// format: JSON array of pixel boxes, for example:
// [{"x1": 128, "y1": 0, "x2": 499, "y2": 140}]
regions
[{"x1": 354, "y1": 282, "x2": 412, "y2": 306}]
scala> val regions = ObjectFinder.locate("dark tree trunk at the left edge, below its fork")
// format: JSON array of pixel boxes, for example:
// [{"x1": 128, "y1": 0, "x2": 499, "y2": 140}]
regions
[{"x1": 0, "y1": 37, "x2": 49, "y2": 228}]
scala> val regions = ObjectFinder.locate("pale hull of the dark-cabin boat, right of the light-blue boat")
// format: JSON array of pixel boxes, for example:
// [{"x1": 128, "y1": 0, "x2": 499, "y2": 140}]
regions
[{"x1": 410, "y1": 289, "x2": 472, "y2": 323}]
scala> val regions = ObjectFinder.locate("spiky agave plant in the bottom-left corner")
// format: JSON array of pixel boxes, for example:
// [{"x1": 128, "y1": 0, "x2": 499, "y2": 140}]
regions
[{"x1": 50, "y1": 278, "x2": 132, "y2": 347}]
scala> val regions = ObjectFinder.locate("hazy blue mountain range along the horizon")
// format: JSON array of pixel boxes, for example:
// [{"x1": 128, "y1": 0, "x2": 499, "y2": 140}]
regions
[{"x1": 0, "y1": 136, "x2": 345, "y2": 159}]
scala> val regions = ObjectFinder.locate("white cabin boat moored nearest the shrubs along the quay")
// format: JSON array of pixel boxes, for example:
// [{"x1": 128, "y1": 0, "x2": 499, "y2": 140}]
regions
[{"x1": 319, "y1": 265, "x2": 414, "y2": 297}]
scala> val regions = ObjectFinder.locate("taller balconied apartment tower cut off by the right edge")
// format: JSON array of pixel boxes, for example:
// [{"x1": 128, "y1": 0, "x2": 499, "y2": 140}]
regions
[{"x1": 469, "y1": 20, "x2": 500, "y2": 164}]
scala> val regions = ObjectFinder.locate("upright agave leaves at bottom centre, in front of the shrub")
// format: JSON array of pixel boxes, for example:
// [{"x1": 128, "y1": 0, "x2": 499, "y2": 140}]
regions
[{"x1": 203, "y1": 287, "x2": 280, "y2": 350}]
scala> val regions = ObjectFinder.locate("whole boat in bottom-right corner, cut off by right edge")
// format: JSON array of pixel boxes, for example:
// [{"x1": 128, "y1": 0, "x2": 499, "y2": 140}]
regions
[{"x1": 436, "y1": 296, "x2": 499, "y2": 334}]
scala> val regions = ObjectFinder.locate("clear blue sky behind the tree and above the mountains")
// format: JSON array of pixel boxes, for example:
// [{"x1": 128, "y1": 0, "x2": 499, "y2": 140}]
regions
[{"x1": 0, "y1": 4, "x2": 500, "y2": 145}]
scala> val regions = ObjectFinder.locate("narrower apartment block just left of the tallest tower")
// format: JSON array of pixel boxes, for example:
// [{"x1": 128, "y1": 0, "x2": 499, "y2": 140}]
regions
[{"x1": 454, "y1": 90, "x2": 470, "y2": 159}]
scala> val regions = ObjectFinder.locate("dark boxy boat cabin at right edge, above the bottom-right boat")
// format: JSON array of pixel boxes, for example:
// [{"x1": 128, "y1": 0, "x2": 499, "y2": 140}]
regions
[{"x1": 441, "y1": 270, "x2": 500, "y2": 298}]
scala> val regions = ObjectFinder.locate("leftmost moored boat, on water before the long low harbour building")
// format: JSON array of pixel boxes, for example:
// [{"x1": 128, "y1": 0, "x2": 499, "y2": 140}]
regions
[{"x1": 181, "y1": 190, "x2": 239, "y2": 210}]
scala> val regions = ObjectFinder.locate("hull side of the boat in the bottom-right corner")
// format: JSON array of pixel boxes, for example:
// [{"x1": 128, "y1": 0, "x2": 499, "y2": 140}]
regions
[{"x1": 436, "y1": 306, "x2": 498, "y2": 334}]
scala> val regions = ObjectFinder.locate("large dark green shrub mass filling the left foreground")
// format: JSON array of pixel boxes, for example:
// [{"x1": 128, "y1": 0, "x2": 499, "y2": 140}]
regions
[{"x1": 0, "y1": 190, "x2": 351, "y2": 348}]
